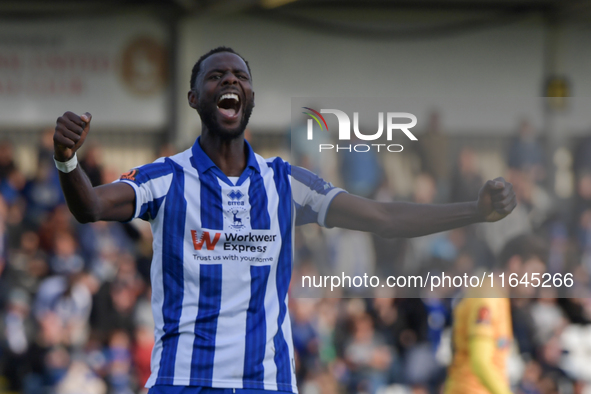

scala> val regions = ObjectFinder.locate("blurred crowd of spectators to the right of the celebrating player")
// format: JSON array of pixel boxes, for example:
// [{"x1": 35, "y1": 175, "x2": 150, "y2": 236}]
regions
[{"x1": 291, "y1": 113, "x2": 591, "y2": 394}]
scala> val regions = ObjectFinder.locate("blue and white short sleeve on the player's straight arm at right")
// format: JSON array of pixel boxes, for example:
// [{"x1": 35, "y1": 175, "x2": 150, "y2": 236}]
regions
[{"x1": 291, "y1": 166, "x2": 345, "y2": 227}]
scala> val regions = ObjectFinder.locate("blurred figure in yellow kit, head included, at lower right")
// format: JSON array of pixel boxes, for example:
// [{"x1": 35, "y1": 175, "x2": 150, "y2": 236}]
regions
[{"x1": 444, "y1": 236, "x2": 544, "y2": 394}]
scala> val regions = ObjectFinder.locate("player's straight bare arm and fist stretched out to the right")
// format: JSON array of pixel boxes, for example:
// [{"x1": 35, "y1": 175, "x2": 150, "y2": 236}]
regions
[{"x1": 326, "y1": 178, "x2": 517, "y2": 238}]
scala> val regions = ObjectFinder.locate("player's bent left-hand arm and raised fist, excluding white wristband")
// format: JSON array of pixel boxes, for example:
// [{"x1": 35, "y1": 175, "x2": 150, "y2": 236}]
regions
[{"x1": 53, "y1": 112, "x2": 135, "y2": 223}]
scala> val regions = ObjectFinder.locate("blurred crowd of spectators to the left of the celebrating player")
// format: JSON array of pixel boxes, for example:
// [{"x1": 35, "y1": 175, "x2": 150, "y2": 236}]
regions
[{"x1": 0, "y1": 130, "x2": 154, "y2": 394}]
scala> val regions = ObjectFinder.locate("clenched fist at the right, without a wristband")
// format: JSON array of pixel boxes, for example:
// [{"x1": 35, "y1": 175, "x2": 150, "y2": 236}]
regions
[{"x1": 477, "y1": 178, "x2": 517, "y2": 222}]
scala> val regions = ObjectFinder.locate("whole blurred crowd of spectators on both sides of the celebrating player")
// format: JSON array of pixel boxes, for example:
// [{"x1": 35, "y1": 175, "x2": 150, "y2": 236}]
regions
[{"x1": 0, "y1": 114, "x2": 591, "y2": 394}]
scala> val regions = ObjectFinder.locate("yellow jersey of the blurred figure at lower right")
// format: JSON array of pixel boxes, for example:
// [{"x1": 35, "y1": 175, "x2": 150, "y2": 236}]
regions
[{"x1": 444, "y1": 298, "x2": 513, "y2": 394}]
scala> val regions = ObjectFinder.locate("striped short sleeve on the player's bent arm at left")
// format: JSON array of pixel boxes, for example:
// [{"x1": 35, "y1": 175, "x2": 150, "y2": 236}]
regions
[{"x1": 116, "y1": 159, "x2": 173, "y2": 221}]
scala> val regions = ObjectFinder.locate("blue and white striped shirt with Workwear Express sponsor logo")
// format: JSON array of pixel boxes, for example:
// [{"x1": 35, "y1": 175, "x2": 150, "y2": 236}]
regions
[{"x1": 120, "y1": 139, "x2": 343, "y2": 392}]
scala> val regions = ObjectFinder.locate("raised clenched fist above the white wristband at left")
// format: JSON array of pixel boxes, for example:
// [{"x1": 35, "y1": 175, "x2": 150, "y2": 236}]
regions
[{"x1": 53, "y1": 111, "x2": 92, "y2": 162}]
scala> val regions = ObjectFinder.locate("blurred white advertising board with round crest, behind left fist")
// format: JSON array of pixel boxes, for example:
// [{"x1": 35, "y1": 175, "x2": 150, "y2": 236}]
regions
[{"x1": 0, "y1": 16, "x2": 169, "y2": 130}]
